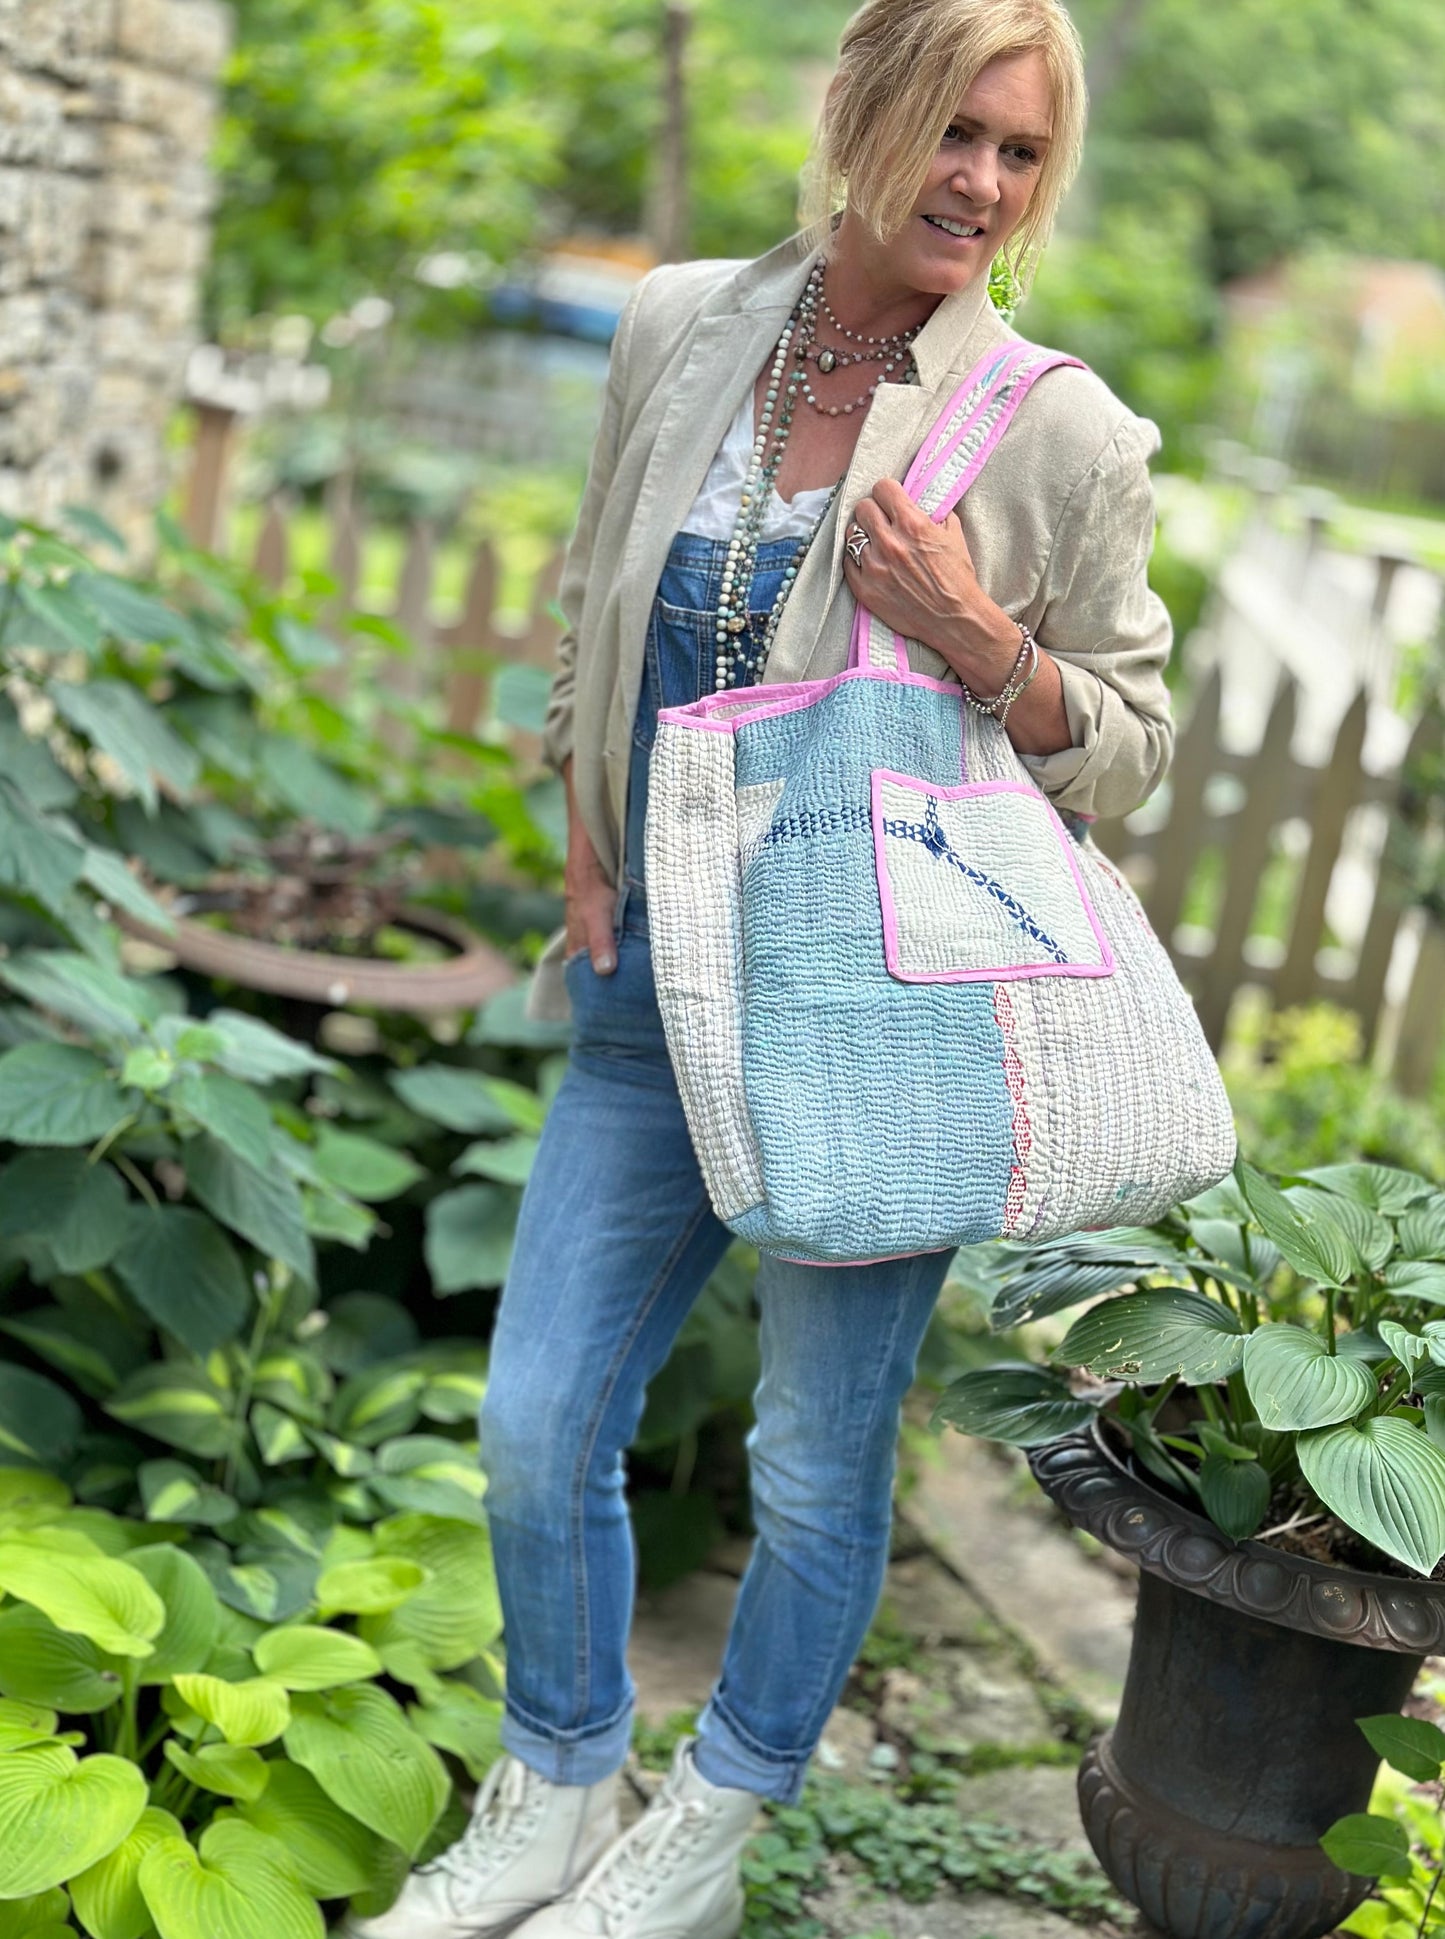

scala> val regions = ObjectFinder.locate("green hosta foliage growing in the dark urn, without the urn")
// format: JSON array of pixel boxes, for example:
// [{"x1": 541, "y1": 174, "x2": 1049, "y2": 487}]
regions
[{"x1": 937, "y1": 1161, "x2": 1445, "y2": 1574}]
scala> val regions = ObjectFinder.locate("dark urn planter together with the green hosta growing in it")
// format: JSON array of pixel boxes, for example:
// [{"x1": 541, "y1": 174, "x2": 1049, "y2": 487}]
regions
[{"x1": 937, "y1": 1163, "x2": 1445, "y2": 1939}]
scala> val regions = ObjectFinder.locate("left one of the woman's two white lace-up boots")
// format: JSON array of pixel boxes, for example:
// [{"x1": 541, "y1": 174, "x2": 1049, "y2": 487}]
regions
[{"x1": 347, "y1": 1757, "x2": 619, "y2": 1939}]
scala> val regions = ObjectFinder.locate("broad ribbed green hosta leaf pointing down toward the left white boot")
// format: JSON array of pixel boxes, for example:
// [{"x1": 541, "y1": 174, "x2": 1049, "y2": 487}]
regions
[{"x1": 285, "y1": 1683, "x2": 442, "y2": 1858}]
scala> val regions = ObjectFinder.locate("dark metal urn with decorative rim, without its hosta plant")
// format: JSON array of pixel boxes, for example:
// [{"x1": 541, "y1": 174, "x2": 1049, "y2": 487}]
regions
[{"x1": 1030, "y1": 1427, "x2": 1445, "y2": 1939}]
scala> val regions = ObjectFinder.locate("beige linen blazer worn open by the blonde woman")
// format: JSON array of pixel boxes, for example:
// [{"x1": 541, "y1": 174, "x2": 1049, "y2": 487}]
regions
[{"x1": 537, "y1": 237, "x2": 1173, "y2": 1010}]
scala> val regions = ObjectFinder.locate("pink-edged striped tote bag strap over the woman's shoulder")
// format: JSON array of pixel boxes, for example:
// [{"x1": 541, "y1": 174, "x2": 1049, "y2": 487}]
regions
[{"x1": 848, "y1": 343, "x2": 1086, "y2": 673}]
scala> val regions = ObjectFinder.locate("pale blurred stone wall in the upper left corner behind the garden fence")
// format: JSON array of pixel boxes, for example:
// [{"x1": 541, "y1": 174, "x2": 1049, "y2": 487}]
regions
[{"x1": 0, "y1": 0, "x2": 229, "y2": 537}]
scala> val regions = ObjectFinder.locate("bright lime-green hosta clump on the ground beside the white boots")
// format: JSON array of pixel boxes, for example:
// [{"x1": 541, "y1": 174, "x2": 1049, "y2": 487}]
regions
[{"x1": 0, "y1": 1468, "x2": 500, "y2": 1939}]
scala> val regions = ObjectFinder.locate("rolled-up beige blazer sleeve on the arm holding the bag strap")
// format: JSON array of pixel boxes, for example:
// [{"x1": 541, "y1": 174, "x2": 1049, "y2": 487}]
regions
[{"x1": 1022, "y1": 417, "x2": 1173, "y2": 816}]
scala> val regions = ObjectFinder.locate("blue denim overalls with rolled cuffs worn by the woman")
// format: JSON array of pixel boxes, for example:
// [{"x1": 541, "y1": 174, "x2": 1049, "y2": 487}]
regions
[{"x1": 481, "y1": 535, "x2": 948, "y2": 1799}]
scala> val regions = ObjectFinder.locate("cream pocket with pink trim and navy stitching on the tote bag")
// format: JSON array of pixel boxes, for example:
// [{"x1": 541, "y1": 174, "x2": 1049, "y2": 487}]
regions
[{"x1": 873, "y1": 768, "x2": 1113, "y2": 983}]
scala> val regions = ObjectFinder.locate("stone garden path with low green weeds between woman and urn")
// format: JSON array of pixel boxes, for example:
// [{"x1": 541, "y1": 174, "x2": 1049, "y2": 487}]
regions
[{"x1": 630, "y1": 1435, "x2": 1135, "y2": 1939}]
